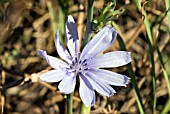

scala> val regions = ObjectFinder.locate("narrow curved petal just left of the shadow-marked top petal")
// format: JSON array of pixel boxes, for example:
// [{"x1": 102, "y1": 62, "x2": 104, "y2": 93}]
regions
[{"x1": 54, "y1": 31, "x2": 71, "y2": 63}]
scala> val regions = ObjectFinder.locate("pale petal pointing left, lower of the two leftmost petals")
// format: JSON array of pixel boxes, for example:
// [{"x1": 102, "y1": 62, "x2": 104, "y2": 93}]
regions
[{"x1": 40, "y1": 69, "x2": 66, "y2": 82}]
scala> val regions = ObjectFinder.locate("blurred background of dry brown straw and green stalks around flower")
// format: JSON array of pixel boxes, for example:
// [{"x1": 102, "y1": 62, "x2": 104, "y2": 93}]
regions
[{"x1": 0, "y1": 0, "x2": 170, "y2": 114}]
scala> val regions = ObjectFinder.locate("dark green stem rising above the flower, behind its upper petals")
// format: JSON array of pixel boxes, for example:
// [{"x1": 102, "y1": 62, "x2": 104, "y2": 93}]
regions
[{"x1": 83, "y1": 0, "x2": 94, "y2": 47}]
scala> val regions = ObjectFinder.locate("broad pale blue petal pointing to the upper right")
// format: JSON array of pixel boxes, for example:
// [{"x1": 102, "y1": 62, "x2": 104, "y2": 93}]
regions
[{"x1": 80, "y1": 26, "x2": 117, "y2": 59}]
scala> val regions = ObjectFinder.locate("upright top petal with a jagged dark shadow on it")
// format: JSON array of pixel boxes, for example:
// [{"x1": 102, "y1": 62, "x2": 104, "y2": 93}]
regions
[{"x1": 65, "y1": 15, "x2": 79, "y2": 57}]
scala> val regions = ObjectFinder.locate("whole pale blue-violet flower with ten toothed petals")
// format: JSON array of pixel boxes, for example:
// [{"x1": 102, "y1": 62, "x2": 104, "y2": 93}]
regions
[{"x1": 38, "y1": 16, "x2": 131, "y2": 106}]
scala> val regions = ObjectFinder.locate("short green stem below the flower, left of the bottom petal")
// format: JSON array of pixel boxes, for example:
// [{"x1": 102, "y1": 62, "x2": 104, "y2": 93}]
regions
[{"x1": 67, "y1": 92, "x2": 74, "y2": 114}]
